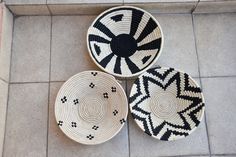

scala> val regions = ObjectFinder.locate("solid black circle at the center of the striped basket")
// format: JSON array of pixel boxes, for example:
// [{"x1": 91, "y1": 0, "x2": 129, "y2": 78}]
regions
[{"x1": 111, "y1": 34, "x2": 137, "y2": 57}]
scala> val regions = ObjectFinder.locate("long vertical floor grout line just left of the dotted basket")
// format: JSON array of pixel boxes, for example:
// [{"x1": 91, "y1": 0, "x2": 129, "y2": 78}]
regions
[{"x1": 46, "y1": 16, "x2": 52, "y2": 157}]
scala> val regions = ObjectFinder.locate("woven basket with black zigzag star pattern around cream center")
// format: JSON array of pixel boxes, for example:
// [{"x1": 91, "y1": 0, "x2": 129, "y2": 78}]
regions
[{"x1": 129, "y1": 68, "x2": 205, "y2": 141}]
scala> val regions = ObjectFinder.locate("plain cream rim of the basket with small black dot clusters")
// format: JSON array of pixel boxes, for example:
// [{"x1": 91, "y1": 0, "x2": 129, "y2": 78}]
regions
[{"x1": 54, "y1": 70, "x2": 129, "y2": 145}]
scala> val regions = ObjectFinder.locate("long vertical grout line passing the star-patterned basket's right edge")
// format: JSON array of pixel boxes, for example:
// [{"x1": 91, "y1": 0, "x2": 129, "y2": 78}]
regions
[{"x1": 191, "y1": 14, "x2": 211, "y2": 157}]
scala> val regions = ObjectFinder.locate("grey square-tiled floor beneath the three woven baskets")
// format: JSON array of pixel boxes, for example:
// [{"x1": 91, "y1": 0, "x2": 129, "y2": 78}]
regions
[{"x1": 3, "y1": 13, "x2": 236, "y2": 157}]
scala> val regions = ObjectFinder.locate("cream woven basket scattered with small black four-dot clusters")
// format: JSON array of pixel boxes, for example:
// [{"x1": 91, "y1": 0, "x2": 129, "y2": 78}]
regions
[{"x1": 55, "y1": 71, "x2": 128, "y2": 145}]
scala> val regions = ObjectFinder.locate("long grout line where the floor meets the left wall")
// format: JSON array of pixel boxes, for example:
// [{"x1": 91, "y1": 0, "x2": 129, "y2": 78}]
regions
[{"x1": 2, "y1": 16, "x2": 15, "y2": 156}]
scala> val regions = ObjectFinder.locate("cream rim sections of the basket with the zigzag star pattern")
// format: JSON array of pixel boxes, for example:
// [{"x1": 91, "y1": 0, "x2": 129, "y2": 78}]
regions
[{"x1": 129, "y1": 66, "x2": 205, "y2": 141}]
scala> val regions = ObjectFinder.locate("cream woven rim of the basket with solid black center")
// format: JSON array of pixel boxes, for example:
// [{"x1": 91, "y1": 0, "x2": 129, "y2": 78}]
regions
[{"x1": 86, "y1": 5, "x2": 164, "y2": 78}]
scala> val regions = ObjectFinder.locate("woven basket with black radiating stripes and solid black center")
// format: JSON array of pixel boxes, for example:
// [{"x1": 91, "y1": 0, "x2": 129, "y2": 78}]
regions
[{"x1": 87, "y1": 6, "x2": 163, "y2": 77}]
